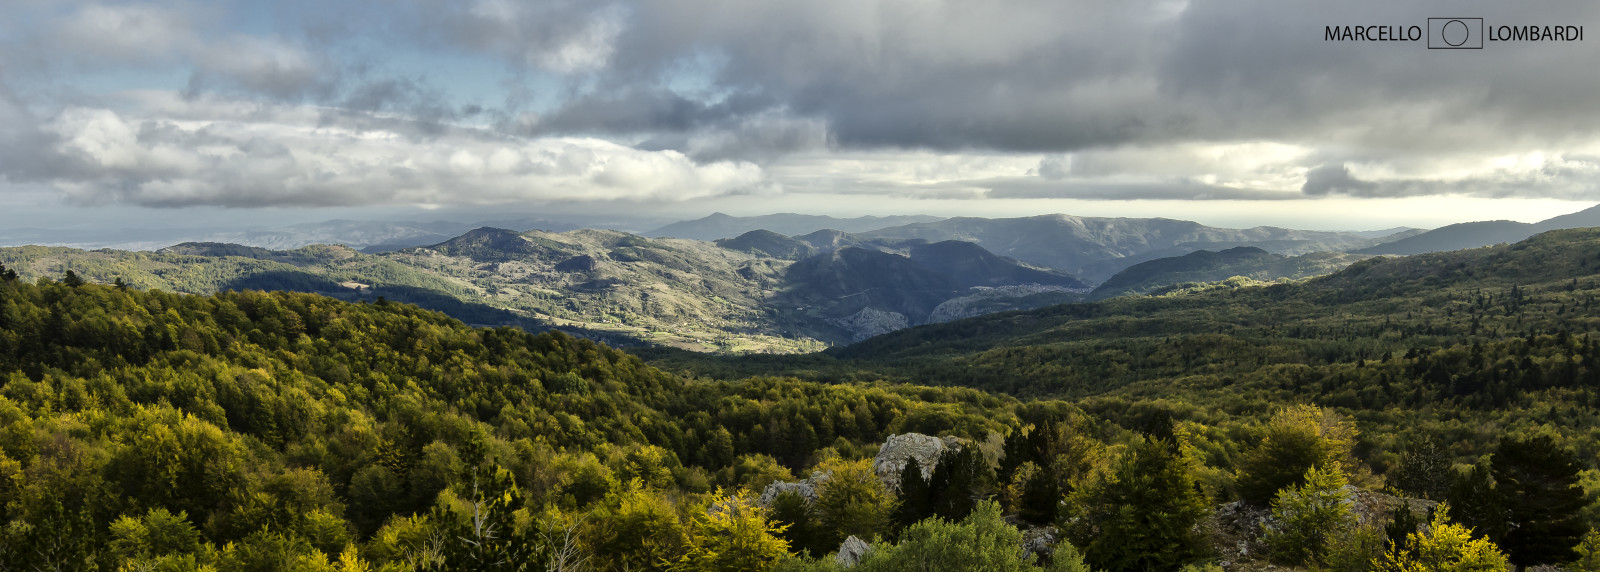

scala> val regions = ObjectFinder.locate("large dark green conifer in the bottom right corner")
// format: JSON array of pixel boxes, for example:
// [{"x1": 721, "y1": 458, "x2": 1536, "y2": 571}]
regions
[{"x1": 1493, "y1": 435, "x2": 1584, "y2": 566}]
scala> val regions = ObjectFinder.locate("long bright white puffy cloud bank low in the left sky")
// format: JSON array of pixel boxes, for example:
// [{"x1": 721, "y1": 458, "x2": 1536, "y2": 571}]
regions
[{"x1": 28, "y1": 101, "x2": 765, "y2": 206}]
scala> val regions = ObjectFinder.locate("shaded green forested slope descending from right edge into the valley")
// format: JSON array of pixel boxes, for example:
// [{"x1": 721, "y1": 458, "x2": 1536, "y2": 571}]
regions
[{"x1": 643, "y1": 222, "x2": 1600, "y2": 397}]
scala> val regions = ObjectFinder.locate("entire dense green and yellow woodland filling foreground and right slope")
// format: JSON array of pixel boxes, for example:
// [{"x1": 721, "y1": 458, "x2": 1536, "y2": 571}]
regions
[{"x1": 0, "y1": 232, "x2": 1600, "y2": 570}]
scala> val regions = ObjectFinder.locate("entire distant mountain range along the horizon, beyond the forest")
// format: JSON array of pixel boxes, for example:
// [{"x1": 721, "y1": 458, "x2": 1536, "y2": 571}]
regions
[{"x1": 0, "y1": 208, "x2": 1600, "y2": 353}]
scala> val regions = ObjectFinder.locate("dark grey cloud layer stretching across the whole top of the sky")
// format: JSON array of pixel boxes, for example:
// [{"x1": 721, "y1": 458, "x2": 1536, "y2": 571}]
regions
[{"x1": 21, "y1": 0, "x2": 1600, "y2": 155}]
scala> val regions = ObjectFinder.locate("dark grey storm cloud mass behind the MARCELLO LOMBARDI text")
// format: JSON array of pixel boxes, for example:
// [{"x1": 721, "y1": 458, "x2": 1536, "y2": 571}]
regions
[{"x1": 473, "y1": 0, "x2": 1600, "y2": 153}]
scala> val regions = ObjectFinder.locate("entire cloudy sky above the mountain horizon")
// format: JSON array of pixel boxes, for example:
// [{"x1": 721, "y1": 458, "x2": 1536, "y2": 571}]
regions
[{"x1": 0, "y1": 0, "x2": 1600, "y2": 233}]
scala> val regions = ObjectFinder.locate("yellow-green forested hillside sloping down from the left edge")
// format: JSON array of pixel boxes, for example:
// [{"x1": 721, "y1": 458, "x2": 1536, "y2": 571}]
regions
[{"x1": 0, "y1": 273, "x2": 1043, "y2": 570}]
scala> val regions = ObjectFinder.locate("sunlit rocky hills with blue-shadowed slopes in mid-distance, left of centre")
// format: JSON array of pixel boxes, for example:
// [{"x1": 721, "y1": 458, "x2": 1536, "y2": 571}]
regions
[{"x1": 0, "y1": 227, "x2": 1088, "y2": 352}]
